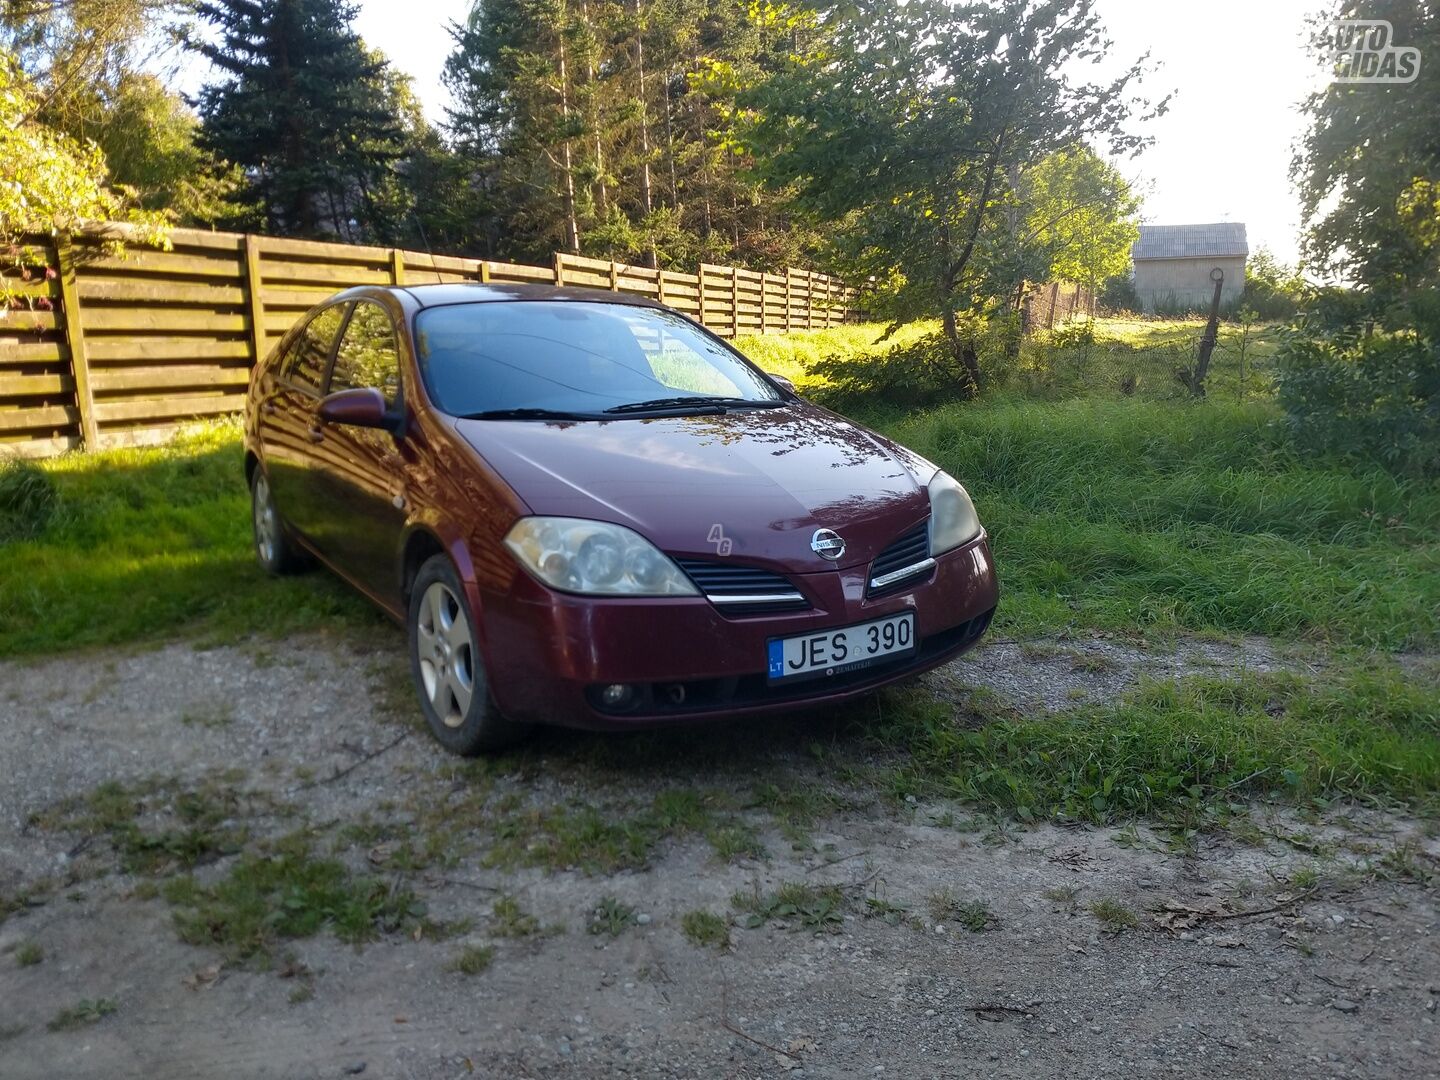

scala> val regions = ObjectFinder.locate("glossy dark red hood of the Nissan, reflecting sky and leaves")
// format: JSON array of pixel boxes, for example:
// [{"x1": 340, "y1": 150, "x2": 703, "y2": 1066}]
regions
[{"x1": 455, "y1": 402, "x2": 935, "y2": 573}]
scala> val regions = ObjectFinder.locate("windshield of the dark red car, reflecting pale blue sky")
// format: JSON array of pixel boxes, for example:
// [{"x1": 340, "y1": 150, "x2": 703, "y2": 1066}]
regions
[{"x1": 415, "y1": 301, "x2": 783, "y2": 416}]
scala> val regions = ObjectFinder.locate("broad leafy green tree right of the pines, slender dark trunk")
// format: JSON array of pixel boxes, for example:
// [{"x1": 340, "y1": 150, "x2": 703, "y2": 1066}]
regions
[{"x1": 747, "y1": 0, "x2": 1140, "y2": 393}]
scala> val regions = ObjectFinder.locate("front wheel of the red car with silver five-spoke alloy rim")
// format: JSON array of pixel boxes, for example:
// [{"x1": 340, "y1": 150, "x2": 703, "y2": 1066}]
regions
[{"x1": 406, "y1": 554, "x2": 530, "y2": 757}]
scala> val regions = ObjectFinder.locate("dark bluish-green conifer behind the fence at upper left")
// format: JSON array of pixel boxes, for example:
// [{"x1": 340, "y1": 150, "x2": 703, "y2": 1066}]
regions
[{"x1": 196, "y1": 0, "x2": 405, "y2": 240}]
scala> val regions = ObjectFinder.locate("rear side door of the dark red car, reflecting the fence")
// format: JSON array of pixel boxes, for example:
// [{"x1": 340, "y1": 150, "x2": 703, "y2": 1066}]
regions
[{"x1": 258, "y1": 302, "x2": 350, "y2": 543}]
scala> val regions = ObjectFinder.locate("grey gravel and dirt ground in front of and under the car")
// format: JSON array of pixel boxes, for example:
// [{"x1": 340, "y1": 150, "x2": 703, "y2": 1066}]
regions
[{"x1": 0, "y1": 631, "x2": 1440, "y2": 1080}]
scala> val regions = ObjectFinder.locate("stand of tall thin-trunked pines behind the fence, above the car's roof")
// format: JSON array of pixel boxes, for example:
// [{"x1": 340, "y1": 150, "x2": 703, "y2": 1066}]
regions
[{"x1": 444, "y1": 0, "x2": 814, "y2": 268}]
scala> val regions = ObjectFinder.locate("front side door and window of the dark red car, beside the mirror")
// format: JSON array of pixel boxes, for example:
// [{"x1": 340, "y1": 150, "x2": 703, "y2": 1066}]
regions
[{"x1": 317, "y1": 300, "x2": 409, "y2": 600}]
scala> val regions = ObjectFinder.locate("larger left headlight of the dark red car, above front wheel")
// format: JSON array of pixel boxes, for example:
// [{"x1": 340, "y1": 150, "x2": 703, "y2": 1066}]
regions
[{"x1": 505, "y1": 517, "x2": 698, "y2": 596}]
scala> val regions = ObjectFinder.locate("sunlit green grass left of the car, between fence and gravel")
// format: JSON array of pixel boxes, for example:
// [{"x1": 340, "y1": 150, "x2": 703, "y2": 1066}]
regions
[{"x1": 0, "y1": 422, "x2": 379, "y2": 657}]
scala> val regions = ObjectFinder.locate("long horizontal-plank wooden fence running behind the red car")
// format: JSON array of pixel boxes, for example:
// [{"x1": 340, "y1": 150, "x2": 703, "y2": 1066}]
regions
[{"x1": 0, "y1": 229, "x2": 858, "y2": 456}]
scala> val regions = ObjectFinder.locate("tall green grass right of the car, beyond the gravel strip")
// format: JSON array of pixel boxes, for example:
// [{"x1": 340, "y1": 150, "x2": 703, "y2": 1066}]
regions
[{"x1": 887, "y1": 399, "x2": 1440, "y2": 648}]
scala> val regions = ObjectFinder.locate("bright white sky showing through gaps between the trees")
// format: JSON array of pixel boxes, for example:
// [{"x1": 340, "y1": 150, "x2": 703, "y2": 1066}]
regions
[{"x1": 187, "y1": 0, "x2": 1336, "y2": 269}]
